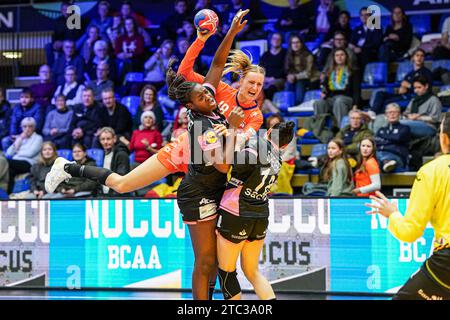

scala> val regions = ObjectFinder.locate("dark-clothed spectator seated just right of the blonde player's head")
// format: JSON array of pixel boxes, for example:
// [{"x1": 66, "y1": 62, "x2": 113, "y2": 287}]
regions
[{"x1": 259, "y1": 32, "x2": 286, "y2": 100}]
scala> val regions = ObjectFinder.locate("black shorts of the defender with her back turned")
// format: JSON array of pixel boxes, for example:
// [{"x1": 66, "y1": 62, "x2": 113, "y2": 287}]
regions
[{"x1": 217, "y1": 209, "x2": 269, "y2": 243}]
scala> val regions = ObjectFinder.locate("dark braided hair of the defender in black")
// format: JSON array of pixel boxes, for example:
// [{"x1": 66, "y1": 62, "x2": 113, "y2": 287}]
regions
[{"x1": 166, "y1": 59, "x2": 197, "y2": 105}]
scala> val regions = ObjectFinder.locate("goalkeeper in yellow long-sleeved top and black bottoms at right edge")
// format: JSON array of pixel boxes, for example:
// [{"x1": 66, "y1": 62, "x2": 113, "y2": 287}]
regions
[{"x1": 366, "y1": 112, "x2": 450, "y2": 300}]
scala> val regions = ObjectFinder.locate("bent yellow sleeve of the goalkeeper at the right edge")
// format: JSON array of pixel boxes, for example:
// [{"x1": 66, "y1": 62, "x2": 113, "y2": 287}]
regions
[{"x1": 388, "y1": 169, "x2": 435, "y2": 242}]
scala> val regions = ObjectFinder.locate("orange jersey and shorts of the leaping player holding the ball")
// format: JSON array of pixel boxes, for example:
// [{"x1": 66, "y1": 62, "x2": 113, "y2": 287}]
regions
[{"x1": 157, "y1": 39, "x2": 263, "y2": 173}]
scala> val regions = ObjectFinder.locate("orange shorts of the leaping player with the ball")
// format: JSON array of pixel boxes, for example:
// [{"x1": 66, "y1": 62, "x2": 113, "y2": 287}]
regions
[{"x1": 156, "y1": 132, "x2": 191, "y2": 173}]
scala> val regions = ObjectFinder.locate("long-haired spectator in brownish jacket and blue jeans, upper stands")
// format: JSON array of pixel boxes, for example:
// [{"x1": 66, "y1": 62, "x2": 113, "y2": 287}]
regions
[{"x1": 284, "y1": 35, "x2": 320, "y2": 105}]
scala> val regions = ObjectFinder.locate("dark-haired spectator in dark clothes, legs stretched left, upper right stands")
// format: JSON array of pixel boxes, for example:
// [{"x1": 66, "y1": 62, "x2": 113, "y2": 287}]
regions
[{"x1": 367, "y1": 49, "x2": 433, "y2": 119}]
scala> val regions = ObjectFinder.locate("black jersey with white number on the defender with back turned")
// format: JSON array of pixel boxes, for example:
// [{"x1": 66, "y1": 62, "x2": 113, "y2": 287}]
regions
[{"x1": 220, "y1": 135, "x2": 281, "y2": 218}]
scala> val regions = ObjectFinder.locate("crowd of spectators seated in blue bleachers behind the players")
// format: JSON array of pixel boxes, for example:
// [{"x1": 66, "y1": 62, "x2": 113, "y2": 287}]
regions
[{"x1": 0, "y1": 0, "x2": 450, "y2": 198}]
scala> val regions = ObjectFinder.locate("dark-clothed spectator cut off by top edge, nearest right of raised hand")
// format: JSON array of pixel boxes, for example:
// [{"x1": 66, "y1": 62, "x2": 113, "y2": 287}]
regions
[{"x1": 274, "y1": 0, "x2": 314, "y2": 34}]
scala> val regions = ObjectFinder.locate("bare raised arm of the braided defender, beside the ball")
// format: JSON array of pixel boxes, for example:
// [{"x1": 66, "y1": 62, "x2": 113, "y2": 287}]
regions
[{"x1": 204, "y1": 9, "x2": 250, "y2": 88}]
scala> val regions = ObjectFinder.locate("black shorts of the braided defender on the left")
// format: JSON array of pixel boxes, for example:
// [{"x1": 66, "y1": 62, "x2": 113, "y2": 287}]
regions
[{"x1": 177, "y1": 189, "x2": 223, "y2": 224}]
